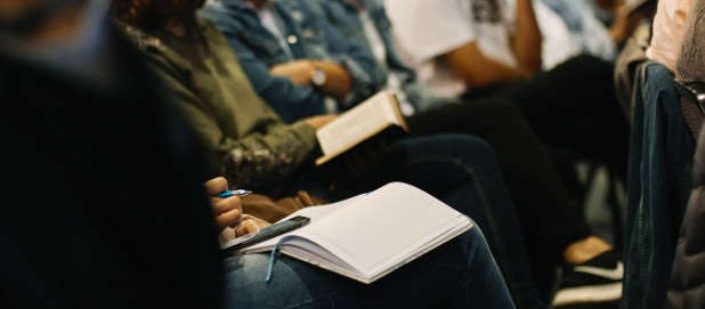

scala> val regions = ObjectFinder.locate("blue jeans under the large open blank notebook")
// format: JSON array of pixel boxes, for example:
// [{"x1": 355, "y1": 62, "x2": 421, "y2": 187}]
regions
[{"x1": 225, "y1": 226, "x2": 514, "y2": 309}]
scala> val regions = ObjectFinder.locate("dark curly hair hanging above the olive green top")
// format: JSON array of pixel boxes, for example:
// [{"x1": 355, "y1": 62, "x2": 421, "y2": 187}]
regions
[{"x1": 110, "y1": 0, "x2": 205, "y2": 31}]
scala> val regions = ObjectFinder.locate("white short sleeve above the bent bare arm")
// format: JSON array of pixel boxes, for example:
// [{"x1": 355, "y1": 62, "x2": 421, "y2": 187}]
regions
[{"x1": 385, "y1": 0, "x2": 476, "y2": 63}]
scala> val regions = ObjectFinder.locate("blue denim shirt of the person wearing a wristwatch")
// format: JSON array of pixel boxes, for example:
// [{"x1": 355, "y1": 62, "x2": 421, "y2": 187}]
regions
[{"x1": 200, "y1": 0, "x2": 382, "y2": 122}]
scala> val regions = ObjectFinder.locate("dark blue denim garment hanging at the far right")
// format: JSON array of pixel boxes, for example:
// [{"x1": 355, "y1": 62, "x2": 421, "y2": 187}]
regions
[{"x1": 622, "y1": 63, "x2": 694, "y2": 309}]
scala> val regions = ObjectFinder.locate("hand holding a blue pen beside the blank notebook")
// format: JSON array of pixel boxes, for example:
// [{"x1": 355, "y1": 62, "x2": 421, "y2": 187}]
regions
[{"x1": 205, "y1": 177, "x2": 242, "y2": 230}]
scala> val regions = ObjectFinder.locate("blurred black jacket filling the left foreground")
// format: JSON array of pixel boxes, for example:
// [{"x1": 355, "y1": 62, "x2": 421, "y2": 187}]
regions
[{"x1": 0, "y1": 27, "x2": 223, "y2": 308}]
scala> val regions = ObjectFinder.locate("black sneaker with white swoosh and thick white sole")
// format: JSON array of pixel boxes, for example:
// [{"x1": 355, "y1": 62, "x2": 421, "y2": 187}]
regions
[{"x1": 553, "y1": 251, "x2": 624, "y2": 308}]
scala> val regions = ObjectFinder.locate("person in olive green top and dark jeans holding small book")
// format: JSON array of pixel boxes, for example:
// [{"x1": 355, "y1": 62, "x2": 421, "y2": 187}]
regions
[{"x1": 113, "y1": 1, "x2": 533, "y2": 306}]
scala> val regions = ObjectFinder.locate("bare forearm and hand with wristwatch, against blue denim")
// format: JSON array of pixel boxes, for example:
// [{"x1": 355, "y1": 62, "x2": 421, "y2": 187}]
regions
[{"x1": 270, "y1": 59, "x2": 352, "y2": 98}]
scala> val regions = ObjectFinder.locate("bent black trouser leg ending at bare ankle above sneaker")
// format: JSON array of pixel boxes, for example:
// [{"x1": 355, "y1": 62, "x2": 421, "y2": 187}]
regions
[{"x1": 408, "y1": 99, "x2": 591, "y2": 297}]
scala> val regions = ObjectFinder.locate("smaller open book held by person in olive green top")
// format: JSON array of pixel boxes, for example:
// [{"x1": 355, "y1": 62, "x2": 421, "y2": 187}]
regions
[{"x1": 316, "y1": 91, "x2": 408, "y2": 165}]
